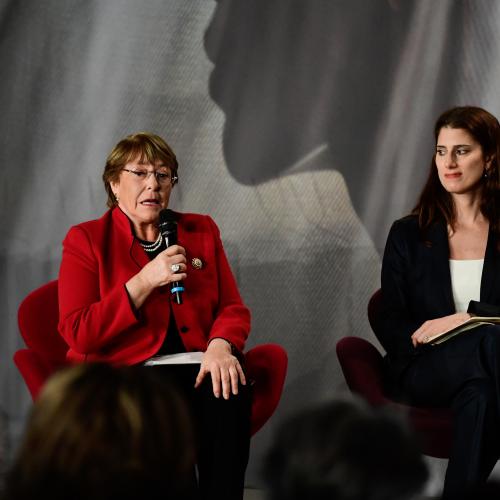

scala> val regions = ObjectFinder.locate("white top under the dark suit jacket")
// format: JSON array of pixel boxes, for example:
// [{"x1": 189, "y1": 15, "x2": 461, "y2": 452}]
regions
[{"x1": 450, "y1": 259, "x2": 484, "y2": 312}]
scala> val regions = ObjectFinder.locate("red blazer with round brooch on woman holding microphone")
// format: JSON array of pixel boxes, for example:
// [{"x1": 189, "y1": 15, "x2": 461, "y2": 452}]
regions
[{"x1": 59, "y1": 208, "x2": 250, "y2": 364}]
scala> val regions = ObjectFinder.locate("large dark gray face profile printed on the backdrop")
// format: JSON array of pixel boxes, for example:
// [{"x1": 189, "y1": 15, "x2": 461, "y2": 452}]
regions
[{"x1": 205, "y1": 0, "x2": 414, "y2": 246}]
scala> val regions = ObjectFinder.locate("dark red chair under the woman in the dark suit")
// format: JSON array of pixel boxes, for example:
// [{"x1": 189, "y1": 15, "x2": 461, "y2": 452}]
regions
[{"x1": 337, "y1": 290, "x2": 452, "y2": 458}]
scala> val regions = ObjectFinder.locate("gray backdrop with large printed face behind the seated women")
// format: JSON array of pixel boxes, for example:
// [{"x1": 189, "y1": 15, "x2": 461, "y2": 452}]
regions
[{"x1": 0, "y1": 0, "x2": 500, "y2": 490}]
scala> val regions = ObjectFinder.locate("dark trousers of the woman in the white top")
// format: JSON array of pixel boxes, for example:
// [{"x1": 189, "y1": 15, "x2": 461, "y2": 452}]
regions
[{"x1": 401, "y1": 325, "x2": 500, "y2": 500}]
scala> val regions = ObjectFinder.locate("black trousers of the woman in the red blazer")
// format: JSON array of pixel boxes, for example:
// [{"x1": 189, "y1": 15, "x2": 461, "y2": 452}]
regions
[{"x1": 153, "y1": 365, "x2": 251, "y2": 500}]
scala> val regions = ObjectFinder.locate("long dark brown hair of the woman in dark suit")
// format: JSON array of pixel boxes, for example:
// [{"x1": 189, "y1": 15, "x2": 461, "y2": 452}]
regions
[{"x1": 412, "y1": 106, "x2": 500, "y2": 233}]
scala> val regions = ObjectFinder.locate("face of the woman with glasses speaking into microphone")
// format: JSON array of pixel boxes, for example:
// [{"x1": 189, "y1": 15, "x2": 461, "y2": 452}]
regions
[{"x1": 110, "y1": 157, "x2": 172, "y2": 232}]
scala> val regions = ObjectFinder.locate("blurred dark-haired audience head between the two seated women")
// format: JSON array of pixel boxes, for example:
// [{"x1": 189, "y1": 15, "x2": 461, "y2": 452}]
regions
[{"x1": 264, "y1": 402, "x2": 428, "y2": 500}]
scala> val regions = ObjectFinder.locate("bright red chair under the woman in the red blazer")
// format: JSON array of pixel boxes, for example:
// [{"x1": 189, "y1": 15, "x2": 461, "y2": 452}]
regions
[{"x1": 14, "y1": 280, "x2": 288, "y2": 435}]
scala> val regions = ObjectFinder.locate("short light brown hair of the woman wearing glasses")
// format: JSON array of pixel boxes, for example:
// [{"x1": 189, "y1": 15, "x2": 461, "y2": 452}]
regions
[{"x1": 102, "y1": 132, "x2": 179, "y2": 208}]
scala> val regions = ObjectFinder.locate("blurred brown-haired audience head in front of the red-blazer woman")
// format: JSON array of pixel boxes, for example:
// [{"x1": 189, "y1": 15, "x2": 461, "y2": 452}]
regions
[{"x1": 6, "y1": 364, "x2": 194, "y2": 500}]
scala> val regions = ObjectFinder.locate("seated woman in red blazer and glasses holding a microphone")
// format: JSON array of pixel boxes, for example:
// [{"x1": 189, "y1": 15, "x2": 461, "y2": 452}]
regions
[{"x1": 59, "y1": 133, "x2": 250, "y2": 500}]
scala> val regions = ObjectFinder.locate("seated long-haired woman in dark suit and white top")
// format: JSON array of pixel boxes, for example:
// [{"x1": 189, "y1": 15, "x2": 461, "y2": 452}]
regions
[{"x1": 377, "y1": 107, "x2": 500, "y2": 499}]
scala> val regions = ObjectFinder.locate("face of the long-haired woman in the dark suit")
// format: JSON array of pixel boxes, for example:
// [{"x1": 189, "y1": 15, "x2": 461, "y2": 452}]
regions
[{"x1": 436, "y1": 127, "x2": 489, "y2": 194}]
